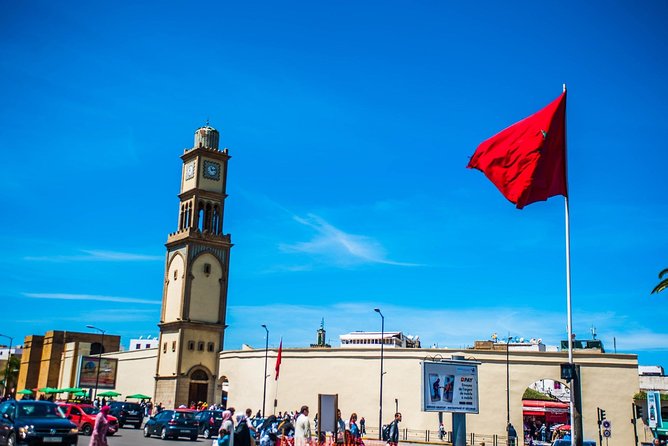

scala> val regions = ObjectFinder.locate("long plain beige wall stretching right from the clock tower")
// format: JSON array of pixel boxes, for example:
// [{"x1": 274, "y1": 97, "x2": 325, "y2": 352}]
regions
[{"x1": 217, "y1": 348, "x2": 638, "y2": 446}]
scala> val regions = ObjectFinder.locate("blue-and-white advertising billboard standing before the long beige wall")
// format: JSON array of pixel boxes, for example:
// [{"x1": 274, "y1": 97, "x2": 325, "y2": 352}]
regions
[{"x1": 422, "y1": 361, "x2": 479, "y2": 413}]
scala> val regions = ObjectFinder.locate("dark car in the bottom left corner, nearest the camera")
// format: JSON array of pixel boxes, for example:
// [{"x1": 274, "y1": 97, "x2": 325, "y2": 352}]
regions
[{"x1": 0, "y1": 400, "x2": 79, "y2": 446}]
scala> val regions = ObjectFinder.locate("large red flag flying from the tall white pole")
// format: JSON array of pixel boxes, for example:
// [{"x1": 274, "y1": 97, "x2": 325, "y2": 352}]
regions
[{"x1": 467, "y1": 92, "x2": 568, "y2": 209}]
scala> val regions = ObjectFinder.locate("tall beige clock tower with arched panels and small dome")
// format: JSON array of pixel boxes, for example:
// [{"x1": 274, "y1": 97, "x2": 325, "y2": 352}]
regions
[{"x1": 155, "y1": 123, "x2": 232, "y2": 407}]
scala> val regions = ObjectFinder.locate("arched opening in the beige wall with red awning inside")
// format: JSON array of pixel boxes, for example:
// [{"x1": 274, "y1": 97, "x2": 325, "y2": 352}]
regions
[{"x1": 522, "y1": 379, "x2": 571, "y2": 444}]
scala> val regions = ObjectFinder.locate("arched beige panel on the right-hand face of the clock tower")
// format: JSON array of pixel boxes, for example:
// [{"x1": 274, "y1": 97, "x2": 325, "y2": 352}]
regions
[{"x1": 188, "y1": 253, "x2": 223, "y2": 323}]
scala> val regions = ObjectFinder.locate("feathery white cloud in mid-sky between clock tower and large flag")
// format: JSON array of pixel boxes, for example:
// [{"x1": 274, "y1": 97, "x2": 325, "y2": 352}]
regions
[{"x1": 280, "y1": 214, "x2": 418, "y2": 266}]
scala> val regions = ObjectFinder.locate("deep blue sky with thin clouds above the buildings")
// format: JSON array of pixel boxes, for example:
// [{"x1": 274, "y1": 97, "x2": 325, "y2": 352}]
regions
[{"x1": 0, "y1": 1, "x2": 668, "y2": 367}]
